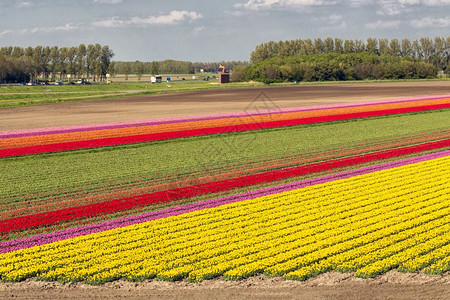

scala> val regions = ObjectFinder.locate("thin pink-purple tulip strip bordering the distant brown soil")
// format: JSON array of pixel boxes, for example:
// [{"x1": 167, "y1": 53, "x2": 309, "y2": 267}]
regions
[{"x1": 0, "y1": 95, "x2": 449, "y2": 139}]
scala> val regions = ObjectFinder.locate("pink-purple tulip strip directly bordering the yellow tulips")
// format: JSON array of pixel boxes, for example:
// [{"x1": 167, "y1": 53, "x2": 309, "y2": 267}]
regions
[{"x1": 0, "y1": 150, "x2": 450, "y2": 253}]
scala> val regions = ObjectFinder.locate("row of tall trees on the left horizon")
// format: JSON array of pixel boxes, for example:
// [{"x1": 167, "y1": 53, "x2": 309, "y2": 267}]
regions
[{"x1": 0, "y1": 44, "x2": 114, "y2": 82}]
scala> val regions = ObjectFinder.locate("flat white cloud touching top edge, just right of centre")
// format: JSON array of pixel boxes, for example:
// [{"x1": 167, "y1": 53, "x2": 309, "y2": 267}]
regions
[{"x1": 234, "y1": 0, "x2": 336, "y2": 10}]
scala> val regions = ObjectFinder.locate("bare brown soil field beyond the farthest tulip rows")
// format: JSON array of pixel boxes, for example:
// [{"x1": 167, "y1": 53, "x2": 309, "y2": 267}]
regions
[{"x1": 0, "y1": 81, "x2": 450, "y2": 131}]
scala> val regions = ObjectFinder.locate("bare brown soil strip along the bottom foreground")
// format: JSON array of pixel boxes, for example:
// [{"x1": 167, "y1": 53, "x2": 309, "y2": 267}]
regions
[{"x1": 0, "y1": 271, "x2": 450, "y2": 300}]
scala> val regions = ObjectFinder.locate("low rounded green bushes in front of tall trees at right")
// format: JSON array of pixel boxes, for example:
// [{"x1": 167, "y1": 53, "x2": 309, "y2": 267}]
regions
[{"x1": 231, "y1": 53, "x2": 437, "y2": 83}]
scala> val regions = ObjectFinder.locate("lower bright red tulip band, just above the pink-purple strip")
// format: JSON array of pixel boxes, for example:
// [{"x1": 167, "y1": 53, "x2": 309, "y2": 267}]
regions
[{"x1": 0, "y1": 139, "x2": 450, "y2": 233}]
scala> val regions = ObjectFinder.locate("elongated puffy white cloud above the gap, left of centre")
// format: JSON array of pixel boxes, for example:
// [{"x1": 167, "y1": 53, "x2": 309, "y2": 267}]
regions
[{"x1": 92, "y1": 10, "x2": 203, "y2": 27}]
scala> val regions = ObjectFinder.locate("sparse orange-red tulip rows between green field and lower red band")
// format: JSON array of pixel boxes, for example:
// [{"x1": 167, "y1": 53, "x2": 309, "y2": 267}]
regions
[{"x1": 0, "y1": 126, "x2": 450, "y2": 223}]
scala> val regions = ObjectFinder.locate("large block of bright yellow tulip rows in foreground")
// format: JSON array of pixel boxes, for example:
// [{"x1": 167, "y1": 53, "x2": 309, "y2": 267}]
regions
[{"x1": 0, "y1": 157, "x2": 450, "y2": 283}]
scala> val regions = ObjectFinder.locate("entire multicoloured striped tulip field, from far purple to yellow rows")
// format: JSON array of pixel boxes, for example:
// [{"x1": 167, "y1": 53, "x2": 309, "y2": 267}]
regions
[{"x1": 0, "y1": 95, "x2": 450, "y2": 284}]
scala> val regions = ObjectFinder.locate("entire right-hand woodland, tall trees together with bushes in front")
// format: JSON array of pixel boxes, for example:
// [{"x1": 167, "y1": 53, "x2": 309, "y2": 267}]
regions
[{"x1": 232, "y1": 37, "x2": 450, "y2": 82}]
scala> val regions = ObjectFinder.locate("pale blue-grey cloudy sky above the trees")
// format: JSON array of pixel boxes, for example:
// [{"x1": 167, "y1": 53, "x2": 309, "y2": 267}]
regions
[{"x1": 0, "y1": 0, "x2": 450, "y2": 61}]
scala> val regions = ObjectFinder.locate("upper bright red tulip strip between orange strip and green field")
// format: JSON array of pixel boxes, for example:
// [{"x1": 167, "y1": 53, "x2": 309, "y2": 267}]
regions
[{"x1": 0, "y1": 103, "x2": 450, "y2": 157}]
